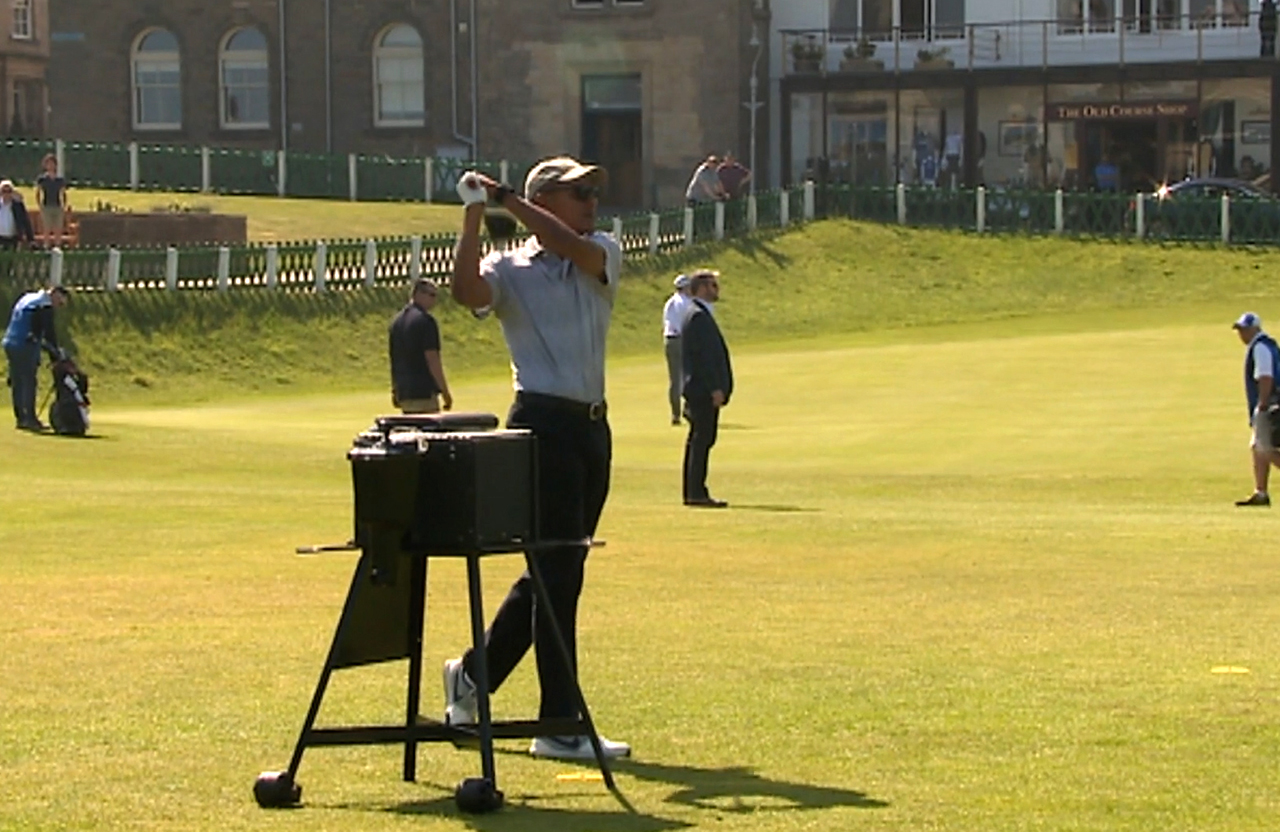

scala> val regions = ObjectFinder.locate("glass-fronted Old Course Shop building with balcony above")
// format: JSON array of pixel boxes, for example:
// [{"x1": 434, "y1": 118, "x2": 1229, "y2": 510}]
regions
[{"x1": 772, "y1": 0, "x2": 1280, "y2": 191}]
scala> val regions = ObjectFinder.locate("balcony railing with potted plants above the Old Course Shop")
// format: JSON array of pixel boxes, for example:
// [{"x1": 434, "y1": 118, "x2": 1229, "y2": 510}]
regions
[{"x1": 782, "y1": 4, "x2": 1276, "y2": 74}]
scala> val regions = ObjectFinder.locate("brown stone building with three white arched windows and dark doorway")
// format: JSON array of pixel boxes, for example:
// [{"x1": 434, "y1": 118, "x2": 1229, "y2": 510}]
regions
[{"x1": 42, "y1": 0, "x2": 769, "y2": 206}]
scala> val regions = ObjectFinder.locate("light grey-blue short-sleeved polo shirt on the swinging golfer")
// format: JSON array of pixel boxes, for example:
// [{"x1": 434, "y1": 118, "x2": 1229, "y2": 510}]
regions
[{"x1": 480, "y1": 232, "x2": 622, "y2": 403}]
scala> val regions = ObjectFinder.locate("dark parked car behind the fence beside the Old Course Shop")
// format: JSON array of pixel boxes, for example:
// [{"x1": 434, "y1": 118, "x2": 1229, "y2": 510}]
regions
[{"x1": 1125, "y1": 178, "x2": 1280, "y2": 239}]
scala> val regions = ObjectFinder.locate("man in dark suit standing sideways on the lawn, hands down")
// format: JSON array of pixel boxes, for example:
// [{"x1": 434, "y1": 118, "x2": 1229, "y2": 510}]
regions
[{"x1": 681, "y1": 270, "x2": 733, "y2": 508}]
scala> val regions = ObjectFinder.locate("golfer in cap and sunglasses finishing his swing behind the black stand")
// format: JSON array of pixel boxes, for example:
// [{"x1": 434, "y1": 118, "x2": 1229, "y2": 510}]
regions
[{"x1": 444, "y1": 156, "x2": 631, "y2": 759}]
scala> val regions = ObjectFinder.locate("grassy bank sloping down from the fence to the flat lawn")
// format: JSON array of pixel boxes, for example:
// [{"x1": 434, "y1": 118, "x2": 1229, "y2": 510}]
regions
[{"x1": 65, "y1": 221, "x2": 1280, "y2": 403}]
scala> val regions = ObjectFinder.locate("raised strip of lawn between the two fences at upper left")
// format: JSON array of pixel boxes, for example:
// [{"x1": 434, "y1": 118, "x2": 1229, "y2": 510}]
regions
[{"x1": 57, "y1": 188, "x2": 461, "y2": 243}]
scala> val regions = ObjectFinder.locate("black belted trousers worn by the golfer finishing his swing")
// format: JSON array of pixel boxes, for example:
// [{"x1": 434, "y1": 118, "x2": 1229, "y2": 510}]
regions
[{"x1": 462, "y1": 398, "x2": 613, "y2": 718}]
